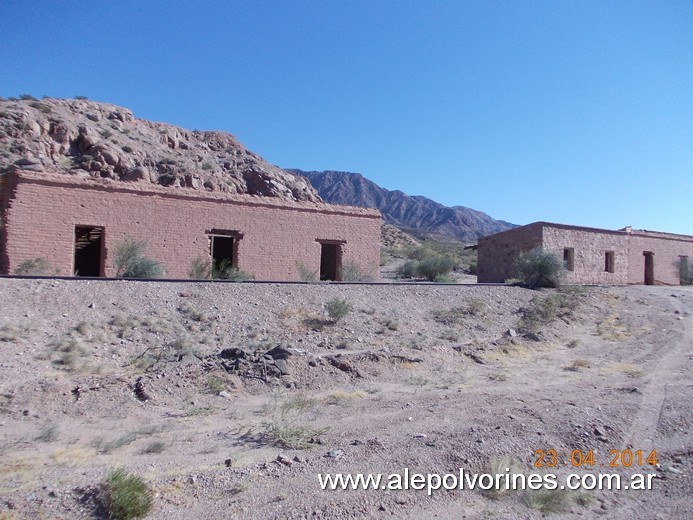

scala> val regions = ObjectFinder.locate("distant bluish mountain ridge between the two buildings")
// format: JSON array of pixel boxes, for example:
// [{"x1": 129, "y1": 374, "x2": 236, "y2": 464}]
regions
[{"x1": 287, "y1": 169, "x2": 516, "y2": 242}]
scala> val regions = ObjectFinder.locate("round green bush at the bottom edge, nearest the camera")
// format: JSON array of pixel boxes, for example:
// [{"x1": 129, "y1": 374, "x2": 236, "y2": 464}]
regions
[{"x1": 103, "y1": 468, "x2": 153, "y2": 520}]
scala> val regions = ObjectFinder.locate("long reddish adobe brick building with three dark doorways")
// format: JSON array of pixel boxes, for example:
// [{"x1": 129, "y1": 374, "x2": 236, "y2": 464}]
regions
[{"x1": 0, "y1": 172, "x2": 381, "y2": 281}]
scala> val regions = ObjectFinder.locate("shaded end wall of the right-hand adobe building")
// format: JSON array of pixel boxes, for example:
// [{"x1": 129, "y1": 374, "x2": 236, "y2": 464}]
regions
[{"x1": 476, "y1": 224, "x2": 541, "y2": 283}]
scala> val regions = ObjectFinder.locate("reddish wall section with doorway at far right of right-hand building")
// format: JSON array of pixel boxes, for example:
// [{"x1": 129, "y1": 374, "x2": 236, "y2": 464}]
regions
[{"x1": 628, "y1": 231, "x2": 693, "y2": 285}]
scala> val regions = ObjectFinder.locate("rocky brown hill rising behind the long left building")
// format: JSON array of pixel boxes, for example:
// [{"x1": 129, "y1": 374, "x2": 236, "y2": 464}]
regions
[{"x1": 0, "y1": 96, "x2": 320, "y2": 201}]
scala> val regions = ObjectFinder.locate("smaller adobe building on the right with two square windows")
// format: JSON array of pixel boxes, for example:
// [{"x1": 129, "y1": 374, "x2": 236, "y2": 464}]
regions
[{"x1": 477, "y1": 222, "x2": 693, "y2": 285}]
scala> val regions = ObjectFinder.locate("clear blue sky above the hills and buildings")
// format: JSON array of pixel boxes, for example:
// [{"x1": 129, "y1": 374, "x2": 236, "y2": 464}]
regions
[{"x1": 0, "y1": 0, "x2": 693, "y2": 234}]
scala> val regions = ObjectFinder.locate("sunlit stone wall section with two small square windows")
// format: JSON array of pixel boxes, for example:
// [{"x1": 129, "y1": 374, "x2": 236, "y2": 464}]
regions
[{"x1": 543, "y1": 225, "x2": 629, "y2": 285}]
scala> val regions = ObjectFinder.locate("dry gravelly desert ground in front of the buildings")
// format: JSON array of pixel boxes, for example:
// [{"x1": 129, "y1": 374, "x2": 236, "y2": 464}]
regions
[{"x1": 0, "y1": 278, "x2": 693, "y2": 520}]
